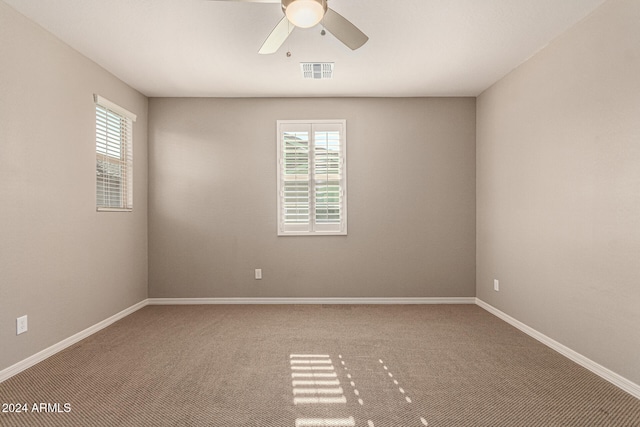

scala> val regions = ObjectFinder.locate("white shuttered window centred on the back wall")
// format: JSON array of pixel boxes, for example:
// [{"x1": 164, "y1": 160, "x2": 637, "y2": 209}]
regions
[{"x1": 278, "y1": 120, "x2": 347, "y2": 236}]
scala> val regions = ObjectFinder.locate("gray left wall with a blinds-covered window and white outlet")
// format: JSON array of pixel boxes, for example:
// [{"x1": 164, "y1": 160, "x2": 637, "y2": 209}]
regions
[{"x1": 0, "y1": 2, "x2": 147, "y2": 370}]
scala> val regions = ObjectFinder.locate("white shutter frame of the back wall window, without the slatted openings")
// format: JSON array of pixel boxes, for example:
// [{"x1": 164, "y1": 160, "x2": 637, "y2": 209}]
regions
[{"x1": 276, "y1": 119, "x2": 347, "y2": 236}]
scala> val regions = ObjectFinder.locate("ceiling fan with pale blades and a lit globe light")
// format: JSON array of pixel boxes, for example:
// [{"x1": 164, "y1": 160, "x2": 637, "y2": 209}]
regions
[{"x1": 213, "y1": 0, "x2": 369, "y2": 54}]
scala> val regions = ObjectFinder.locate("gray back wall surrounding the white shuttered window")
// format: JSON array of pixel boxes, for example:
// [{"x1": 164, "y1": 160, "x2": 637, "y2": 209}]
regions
[{"x1": 149, "y1": 98, "x2": 475, "y2": 297}]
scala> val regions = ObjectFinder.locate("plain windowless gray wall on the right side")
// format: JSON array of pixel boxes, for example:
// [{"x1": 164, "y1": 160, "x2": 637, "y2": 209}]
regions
[{"x1": 477, "y1": 0, "x2": 640, "y2": 384}]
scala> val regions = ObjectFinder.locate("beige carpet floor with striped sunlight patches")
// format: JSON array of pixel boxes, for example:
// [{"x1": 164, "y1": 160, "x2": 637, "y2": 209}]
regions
[{"x1": 0, "y1": 305, "x2": 640, "y2": 427}]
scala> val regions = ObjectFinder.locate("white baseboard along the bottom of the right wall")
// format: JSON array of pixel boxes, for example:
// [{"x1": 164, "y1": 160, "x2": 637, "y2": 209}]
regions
[{"x1": 476, "y1": 298, "x2": 640, "y2": 399}]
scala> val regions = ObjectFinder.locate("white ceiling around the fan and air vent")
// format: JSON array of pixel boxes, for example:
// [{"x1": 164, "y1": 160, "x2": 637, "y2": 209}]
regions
[{"x1": 4, "y1": 0, "x2": 604, "y2": 97}]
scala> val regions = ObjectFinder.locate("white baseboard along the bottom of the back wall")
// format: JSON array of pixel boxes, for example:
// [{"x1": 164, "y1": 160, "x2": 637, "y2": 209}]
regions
[{"x1": 148, "y1": 297, "x2": 476, "y2": 305}]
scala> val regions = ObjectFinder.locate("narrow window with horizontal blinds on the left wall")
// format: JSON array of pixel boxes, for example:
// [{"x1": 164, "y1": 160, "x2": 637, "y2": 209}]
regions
[{"x1": 94, "y1": 95, "x2": 136, "y2": 211}]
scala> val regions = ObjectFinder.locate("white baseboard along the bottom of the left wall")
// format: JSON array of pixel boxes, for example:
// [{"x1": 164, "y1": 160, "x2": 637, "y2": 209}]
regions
[{"x1": 0, "y1": 299, "x2": 147, "y2": 383}]
